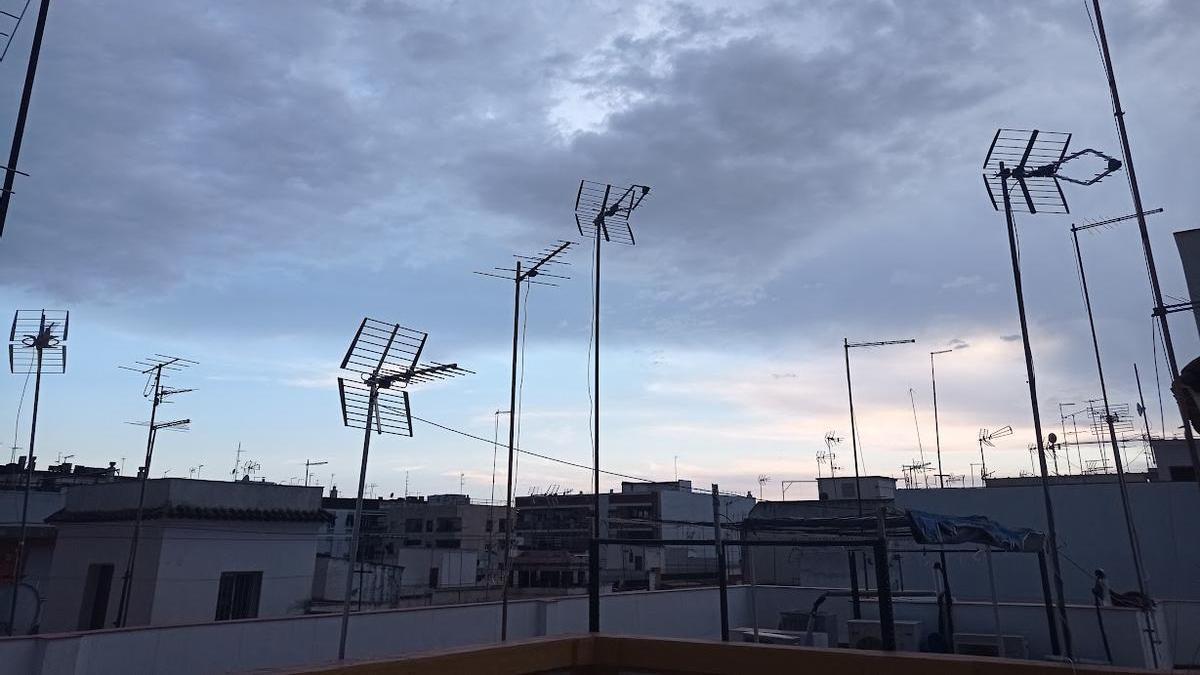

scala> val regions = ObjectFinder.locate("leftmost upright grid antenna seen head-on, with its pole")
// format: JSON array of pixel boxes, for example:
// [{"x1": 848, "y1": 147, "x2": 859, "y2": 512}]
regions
[{"x1": 0, "y1": 307, "x2": 71, "y2": 635}]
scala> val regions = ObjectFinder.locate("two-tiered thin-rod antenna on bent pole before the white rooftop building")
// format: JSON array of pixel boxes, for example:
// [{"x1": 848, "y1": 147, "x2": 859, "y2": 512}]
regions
[{"x1": 115, "y1": 354, "x2": 198, "y2": 628}]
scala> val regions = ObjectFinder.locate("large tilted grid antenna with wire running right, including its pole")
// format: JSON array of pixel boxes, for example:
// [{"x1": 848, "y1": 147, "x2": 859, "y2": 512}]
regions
[{"x1": 337, "y1": 317, "x2": 470, "y2": 661}]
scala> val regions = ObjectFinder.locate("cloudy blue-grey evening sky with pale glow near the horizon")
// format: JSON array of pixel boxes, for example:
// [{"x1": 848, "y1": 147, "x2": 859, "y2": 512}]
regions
[{"x1": 0, "y1": 0, "x2": 1200, "y2": 500}]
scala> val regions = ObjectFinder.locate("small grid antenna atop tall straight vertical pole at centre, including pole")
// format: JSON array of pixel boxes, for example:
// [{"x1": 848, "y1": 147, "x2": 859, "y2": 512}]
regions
[{"x1": 575, "y1": 180, "x2": 650, "y2": 633}]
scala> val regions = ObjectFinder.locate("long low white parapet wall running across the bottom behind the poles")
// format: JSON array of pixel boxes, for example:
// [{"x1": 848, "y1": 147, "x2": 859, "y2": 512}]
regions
[{"x1": 0, "y1": 586, "x2": 1176, "y2": 675}]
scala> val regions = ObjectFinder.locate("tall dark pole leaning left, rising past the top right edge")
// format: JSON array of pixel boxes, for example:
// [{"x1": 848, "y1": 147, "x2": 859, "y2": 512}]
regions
[{"x1": 1092, "y1": 0, "x2": 1200, "y2": 485}]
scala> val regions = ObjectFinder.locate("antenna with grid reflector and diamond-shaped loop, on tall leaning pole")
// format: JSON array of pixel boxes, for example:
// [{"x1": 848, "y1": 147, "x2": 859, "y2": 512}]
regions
[{"x1": 983, "y1": 129, "x2": 1121, "y2": 657}]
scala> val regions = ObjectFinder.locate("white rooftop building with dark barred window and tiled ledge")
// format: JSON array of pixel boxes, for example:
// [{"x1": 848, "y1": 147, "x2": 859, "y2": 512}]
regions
[{"x1": 42, "y1": 478, "x2": 329, "y2": 632}]
